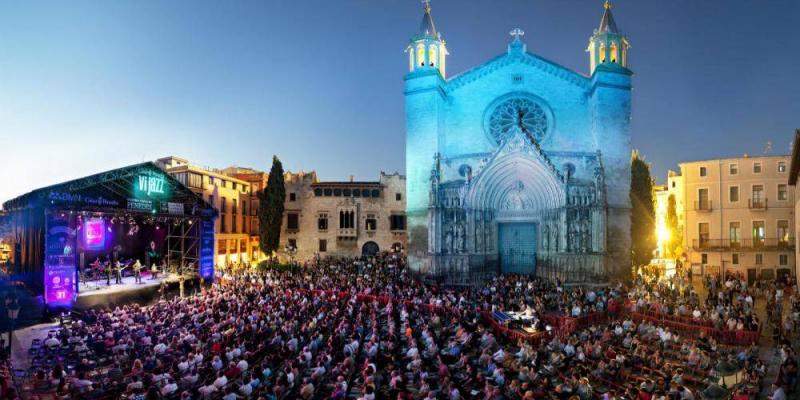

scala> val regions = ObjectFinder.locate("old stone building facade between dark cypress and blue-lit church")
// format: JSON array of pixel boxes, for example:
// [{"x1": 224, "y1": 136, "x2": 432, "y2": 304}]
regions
[{"x1": 281, "y1": 171, "x2": 406, "y2": 261}]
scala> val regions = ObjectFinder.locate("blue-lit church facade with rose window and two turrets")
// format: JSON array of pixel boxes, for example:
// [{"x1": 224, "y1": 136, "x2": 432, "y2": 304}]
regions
[{"x1": 405, "y1": 4, "x2": 632, "y2": 282}]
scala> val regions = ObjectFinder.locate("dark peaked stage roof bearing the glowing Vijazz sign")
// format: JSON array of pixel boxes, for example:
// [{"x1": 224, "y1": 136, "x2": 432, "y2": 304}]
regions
[{"x1": 3, "y1": 162, "x2": 215, "y2": 215}]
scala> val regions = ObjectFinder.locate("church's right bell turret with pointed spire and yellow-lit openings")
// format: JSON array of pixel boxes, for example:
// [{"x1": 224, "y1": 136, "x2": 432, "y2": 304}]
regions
[{"x1": 586, "y1": 0, "x2": 630, "y2": 74}]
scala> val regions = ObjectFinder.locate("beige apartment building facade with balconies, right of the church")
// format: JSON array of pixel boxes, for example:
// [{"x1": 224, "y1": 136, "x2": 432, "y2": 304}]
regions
[{"x1": 666, "y1": 156, "x2": 796, "y2": 282}]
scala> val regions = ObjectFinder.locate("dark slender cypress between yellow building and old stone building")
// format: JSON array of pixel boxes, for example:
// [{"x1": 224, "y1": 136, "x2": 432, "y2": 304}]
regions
[{"x1": 258, "y1": 156, "x2": 286, "y2": 256}]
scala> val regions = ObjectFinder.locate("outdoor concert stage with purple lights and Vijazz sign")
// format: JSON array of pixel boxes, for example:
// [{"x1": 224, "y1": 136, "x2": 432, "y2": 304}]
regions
[{"x1": 3, "y1": 162, "x2": 217, "y2": 310}]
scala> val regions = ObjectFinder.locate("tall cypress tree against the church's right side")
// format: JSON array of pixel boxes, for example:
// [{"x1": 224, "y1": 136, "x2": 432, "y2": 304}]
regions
[{"x1": 630, "y1": 151, "x2": 656, "y2": 268}]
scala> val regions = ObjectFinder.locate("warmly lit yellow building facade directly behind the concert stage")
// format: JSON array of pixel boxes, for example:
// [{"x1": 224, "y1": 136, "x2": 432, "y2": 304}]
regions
[{"x1": 155, "y1": 156, "x2": 258, "y2": 266}]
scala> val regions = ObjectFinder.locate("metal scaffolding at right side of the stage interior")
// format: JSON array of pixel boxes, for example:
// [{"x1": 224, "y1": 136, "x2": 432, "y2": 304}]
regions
[{"x1": 166, "y1": 217, "x2": 200, "y2": 274}]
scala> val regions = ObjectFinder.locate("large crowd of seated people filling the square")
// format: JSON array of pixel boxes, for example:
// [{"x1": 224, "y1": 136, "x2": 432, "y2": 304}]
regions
[{"x1": 18, "y1": 255, "x2": 788, "y2": 400}]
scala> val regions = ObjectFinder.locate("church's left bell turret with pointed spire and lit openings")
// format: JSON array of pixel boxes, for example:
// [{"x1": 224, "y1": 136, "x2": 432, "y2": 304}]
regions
[{"x1": 406, "y1": 0, "x2": 449, "y2": 78}]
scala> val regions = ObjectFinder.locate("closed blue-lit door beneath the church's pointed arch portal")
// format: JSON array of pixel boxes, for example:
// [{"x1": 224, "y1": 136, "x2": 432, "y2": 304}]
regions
[{"x1": 497, "y1": 223, "x2": 536, "y2": 274}]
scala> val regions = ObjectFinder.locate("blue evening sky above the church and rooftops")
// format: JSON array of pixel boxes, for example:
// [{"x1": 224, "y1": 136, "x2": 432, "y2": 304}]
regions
[{"x1": 0, "y1": 0, "x2": 800, "y2": 201}]
